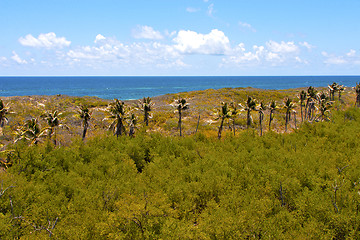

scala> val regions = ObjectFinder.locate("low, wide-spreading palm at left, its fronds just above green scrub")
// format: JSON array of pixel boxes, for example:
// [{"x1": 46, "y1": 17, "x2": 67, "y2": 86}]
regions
[{"x1": 15, "y1": 118, "x2": 49, "y2": 145}]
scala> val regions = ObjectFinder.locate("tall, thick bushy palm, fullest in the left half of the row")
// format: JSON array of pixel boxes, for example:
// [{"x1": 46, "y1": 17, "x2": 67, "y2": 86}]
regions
[{"x1": 105, "y1": 99, "x2": 127, "y2": 137}]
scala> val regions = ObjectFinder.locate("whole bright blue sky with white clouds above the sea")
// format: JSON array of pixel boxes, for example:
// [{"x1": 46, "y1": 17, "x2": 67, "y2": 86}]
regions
[{"x1": 0, "y1": 0, "x2": 360, "y2": 76}]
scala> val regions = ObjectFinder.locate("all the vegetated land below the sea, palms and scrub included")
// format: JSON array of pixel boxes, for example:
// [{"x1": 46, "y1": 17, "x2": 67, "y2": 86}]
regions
[{"x1": 0, "y1": 84, "x2": 360, "y2": 239}]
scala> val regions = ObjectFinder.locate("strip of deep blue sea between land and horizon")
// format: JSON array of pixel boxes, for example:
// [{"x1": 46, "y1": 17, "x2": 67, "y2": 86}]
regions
[{"x1": 0, "y1": 76, "x2": 360, "y2": 100}]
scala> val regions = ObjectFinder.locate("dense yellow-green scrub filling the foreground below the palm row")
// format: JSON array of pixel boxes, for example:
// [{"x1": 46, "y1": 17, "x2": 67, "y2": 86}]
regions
[{"x1": 0, "y1": 84, "x2": 360, "y2": 239}]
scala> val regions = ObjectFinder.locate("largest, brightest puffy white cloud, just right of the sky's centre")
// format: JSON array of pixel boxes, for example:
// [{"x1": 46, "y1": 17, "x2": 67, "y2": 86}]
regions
[{"x1": 174, "y1": 29, "x2": 230, "y2": 55}]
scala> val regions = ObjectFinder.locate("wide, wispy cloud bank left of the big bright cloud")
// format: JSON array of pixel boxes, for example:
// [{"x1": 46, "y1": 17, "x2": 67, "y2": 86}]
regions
[{"x1": 63, "y1": 35, "x2": 187, "y2": 69}]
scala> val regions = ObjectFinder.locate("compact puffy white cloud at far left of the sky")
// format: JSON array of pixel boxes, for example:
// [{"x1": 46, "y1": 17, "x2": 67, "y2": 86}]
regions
[{"x1": 19, "y1": 32, "x2": 71, "y2": 49}]
